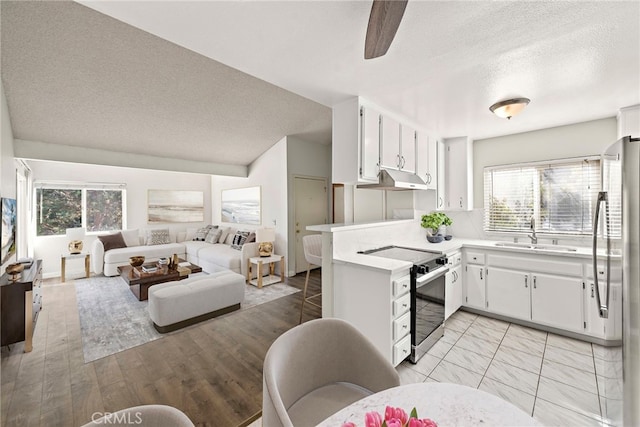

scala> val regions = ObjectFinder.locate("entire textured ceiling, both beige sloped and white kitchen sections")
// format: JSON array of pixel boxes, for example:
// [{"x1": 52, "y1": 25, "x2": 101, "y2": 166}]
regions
[{"x1": 1, "y1": 0, "x2": 640, "y2": 174}]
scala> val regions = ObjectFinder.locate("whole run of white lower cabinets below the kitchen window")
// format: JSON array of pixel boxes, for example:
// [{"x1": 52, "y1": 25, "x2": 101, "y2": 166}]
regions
[{"x1": 463, "y1": 249, "x2": 622, "y2": 340}]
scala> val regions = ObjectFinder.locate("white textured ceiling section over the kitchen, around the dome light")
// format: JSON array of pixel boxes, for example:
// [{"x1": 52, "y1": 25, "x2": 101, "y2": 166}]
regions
[{"x1": 83, "y1": 0, "x2": 640, "y2": 139}]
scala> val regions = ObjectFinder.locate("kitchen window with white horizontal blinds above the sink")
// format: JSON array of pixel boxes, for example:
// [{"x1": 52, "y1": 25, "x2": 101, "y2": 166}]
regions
[{"x1": 484, "y1": 157, "x2": 600, "y2": 235}]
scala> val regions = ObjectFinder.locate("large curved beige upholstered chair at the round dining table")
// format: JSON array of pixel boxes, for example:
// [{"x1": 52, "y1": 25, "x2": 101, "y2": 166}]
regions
[{"x1": 262, "y1": 318, "x2": 400, "y2": 427}]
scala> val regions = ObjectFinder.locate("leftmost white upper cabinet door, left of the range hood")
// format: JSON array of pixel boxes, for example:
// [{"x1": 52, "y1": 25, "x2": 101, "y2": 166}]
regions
[{"x1": 360, "y1": 107, "x2": 380, "y2": 181}]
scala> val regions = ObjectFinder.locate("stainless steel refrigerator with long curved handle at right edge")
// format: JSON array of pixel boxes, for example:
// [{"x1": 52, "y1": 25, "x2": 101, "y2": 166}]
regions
[{"x1": 593, "y1": 136, "x2": 640, "y2": 427}]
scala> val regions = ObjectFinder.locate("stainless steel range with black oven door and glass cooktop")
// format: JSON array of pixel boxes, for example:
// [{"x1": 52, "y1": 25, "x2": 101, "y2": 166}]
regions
[{"x1": 359, "y1": 246, "x2": 449, "y2": 363}]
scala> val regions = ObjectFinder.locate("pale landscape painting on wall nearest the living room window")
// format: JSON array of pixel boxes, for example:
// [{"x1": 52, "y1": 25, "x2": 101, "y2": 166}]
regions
[{"x1": 147, "y1": 190, "x2": 204, "y2": 224}]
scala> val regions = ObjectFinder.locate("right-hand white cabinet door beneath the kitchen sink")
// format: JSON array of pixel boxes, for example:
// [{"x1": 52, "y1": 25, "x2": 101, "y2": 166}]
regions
[{"x1": 531, "y1": 273, "x2": 584, "y2": 332}]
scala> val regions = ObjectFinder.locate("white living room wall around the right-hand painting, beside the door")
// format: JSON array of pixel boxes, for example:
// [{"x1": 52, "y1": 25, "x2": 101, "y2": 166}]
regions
[{"x1": 211, "y1": 138, "x2": 288, "y2": 268}]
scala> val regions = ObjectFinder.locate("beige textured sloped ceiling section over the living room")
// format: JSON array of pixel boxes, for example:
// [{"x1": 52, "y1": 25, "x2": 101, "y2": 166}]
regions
[{"x1": 1, "y1": 1, "x2": 331, "y2": 169}]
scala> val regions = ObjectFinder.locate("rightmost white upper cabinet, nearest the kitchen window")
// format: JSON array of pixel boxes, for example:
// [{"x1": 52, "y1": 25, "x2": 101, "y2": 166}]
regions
[{"x1": 445, "y1": 137, "x2": 473, "y2": 210}]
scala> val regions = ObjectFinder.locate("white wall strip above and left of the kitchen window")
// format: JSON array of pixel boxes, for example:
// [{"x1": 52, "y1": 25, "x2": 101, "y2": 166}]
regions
[{"x1": 473, "y1": 117, "x2": 617, "y2": 208}]
